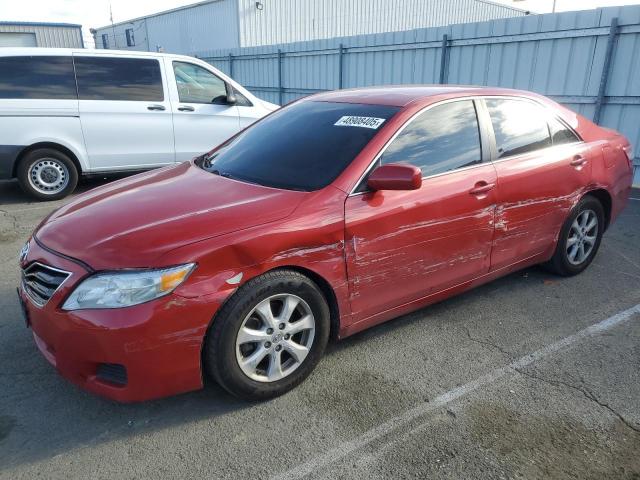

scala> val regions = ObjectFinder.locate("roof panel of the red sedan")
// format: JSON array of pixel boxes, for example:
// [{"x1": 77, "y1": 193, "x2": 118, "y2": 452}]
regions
[{"x1": 308, "y1": 85, "x2": 537, "y2": 107}]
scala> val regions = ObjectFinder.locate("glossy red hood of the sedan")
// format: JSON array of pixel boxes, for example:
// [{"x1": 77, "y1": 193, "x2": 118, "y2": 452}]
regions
[{"x1": 36, "y1": 163, "x2": 306, "y2": 270}]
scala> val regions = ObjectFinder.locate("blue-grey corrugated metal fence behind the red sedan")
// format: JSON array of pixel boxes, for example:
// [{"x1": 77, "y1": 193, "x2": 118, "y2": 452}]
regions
[{"x1": 199, "y1": 6, "x2": 640, "y2": 184}]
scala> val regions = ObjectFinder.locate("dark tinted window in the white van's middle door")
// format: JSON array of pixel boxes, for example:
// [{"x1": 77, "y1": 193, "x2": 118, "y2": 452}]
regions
[{"x1": 74, "y1": 56, "x2": 164, "y2": 102}]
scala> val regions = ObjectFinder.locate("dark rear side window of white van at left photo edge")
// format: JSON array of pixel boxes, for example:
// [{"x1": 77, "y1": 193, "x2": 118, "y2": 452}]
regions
[{"x1": 0, "y1": 56, "x2": 77, "y2": 100}]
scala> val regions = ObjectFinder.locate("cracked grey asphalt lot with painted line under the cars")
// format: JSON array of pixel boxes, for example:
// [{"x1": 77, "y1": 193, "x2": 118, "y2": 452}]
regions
[{"x1": 0, "y1": 177, "x2": 640, "y2": 480}]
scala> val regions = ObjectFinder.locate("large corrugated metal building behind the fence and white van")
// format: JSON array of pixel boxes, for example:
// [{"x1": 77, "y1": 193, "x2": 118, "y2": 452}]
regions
[{"x1": 92, "y1": 0, "x2": 527, "y2": 54}]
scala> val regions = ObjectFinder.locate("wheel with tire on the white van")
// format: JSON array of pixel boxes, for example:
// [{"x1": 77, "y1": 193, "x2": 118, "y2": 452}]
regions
[{"x1": 18, "y1": 148, "x2": 78, "y2": 200}]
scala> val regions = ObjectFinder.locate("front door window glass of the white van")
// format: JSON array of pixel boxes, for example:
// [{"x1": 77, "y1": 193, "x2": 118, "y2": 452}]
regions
[{"x1": 173, "y1": 62, "x2": 227, "y2": 104}]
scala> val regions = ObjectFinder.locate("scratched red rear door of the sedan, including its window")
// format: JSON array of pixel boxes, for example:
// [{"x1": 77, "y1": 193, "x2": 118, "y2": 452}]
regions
[{"x1": 485, "y1": 97, "x2": 601, "y2": 270}]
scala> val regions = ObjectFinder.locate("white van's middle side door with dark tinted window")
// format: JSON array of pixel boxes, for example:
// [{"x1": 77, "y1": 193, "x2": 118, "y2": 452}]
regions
[{"x1": 74, "y1": 54, "x2": 175, "y2": 171}]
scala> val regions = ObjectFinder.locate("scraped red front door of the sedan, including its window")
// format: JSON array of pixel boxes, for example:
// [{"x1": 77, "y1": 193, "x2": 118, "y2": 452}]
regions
[{"x1": 345, "y1": 99, "x2": 496, "y2": 322}]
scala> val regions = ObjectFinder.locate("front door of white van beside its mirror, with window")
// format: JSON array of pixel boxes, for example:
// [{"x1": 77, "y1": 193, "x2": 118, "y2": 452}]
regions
[{"x1": 165, "y1": 58, "x2": 244, "y2": 162}]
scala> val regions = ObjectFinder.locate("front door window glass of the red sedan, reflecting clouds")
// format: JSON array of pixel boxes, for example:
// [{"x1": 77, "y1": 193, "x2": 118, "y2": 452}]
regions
[{"x1": 380, "y1": 100, "x2": 482, "y2": 177}]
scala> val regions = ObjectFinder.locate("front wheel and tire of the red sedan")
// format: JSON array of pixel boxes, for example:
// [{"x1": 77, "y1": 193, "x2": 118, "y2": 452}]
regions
[{"x1": 204, "y1": 270, "x2": 330, "y2": 400}]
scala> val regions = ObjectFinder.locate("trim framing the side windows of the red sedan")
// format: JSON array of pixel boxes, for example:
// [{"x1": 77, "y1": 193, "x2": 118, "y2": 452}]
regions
[{"x1": 347, "y1": 95, "x2": 585, "y2": 197}]
